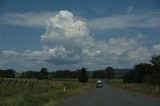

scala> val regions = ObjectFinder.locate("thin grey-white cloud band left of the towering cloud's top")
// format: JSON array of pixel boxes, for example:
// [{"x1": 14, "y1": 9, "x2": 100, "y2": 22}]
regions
[{"x1": 0, "y1": 12, "x2": 56, "y2": 27}]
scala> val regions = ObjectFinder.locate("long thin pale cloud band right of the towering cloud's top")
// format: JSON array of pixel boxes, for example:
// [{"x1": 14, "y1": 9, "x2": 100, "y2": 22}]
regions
[{"x1": 88, "y1": 13, "x2": 160, "y2": 30}]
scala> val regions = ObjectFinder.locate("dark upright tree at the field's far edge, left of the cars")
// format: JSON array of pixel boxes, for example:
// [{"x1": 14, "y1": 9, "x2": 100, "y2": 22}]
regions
[{"x1": 78, "y1": 67, "x2": 88, "y2": 83}]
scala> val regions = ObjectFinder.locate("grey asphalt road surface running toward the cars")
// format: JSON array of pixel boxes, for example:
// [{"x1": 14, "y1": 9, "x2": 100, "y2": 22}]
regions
[{"x1": 59, "y1": 85, "x2": 160, "y2": 106}]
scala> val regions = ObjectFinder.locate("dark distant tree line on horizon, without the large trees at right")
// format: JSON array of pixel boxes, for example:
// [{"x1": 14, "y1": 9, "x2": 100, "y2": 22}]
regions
[{"x1": 0, "y1": 67, "x2": 114, "y2": 83}]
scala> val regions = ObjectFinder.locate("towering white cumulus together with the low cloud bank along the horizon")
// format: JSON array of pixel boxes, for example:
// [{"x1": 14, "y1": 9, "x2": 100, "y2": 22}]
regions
[{"x1": 0, "y1": 10, "x2": 154, "y2": 69}]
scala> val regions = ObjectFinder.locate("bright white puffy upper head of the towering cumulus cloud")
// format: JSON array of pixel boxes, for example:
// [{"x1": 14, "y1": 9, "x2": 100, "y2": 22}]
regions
[{"x1": 42, "y1": 11, "x2": 92, "y2": 47}]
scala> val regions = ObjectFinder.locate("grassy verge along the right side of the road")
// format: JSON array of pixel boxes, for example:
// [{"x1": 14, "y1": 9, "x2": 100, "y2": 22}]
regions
[{"x1": 109, "y1": 79, "x2": 160, "y2": 99}]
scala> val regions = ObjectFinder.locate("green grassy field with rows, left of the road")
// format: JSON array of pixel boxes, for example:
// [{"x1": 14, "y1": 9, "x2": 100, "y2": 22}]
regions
[{"x1": 0, "y1": 79, "x2": 95, "y2": 106}]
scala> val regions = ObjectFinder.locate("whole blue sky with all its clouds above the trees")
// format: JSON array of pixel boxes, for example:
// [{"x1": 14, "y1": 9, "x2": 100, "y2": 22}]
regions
[{"x1": 0, "y1": 0, "x2": 160, "y2": 72}]
